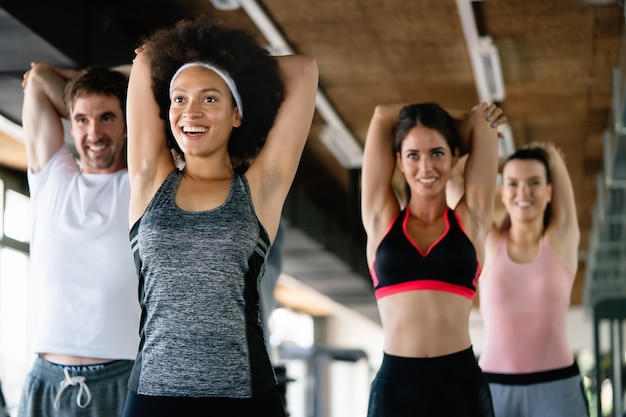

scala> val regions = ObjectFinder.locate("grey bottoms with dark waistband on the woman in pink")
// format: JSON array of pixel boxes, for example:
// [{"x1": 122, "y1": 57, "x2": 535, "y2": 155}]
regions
[{"x1": 484, "y1": 364, "x2": 589, "y2": 417}]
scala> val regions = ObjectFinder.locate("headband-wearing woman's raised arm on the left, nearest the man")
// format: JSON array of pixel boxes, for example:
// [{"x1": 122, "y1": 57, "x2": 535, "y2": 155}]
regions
[{"x1": 126, "y1": 48, "x2": 174, "y2": 225}]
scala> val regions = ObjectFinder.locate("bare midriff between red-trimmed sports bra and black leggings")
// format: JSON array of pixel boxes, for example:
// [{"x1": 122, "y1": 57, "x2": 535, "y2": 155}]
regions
[{"x1": 378, "y1": 290, "x2": 472, "y2": 358}]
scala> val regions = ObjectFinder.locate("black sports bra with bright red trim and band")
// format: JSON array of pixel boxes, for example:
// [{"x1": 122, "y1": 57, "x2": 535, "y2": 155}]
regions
[{"x1": 370, "y1": 208, "x2": 481, "y2": 300}]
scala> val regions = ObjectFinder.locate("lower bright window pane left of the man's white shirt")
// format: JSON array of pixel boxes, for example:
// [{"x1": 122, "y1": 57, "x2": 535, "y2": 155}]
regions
[{"x1": 0, "y1": 248, "x2": 34, "y2": 415}]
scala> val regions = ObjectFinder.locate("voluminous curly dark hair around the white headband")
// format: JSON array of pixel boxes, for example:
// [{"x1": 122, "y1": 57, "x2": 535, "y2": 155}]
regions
[{"x1": 143, "y1": 16, "x2": 285, "y2": 173}]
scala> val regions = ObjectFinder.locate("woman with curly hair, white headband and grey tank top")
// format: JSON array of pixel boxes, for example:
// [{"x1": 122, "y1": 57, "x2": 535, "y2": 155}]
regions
[{"x1": 123, "y1": 17, "x2": 318, "y2": 417}]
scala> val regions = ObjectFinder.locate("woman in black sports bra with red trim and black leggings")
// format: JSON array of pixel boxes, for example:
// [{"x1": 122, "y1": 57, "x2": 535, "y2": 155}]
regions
[{"x1": 362, "y1": 103, "x2": 506, "y2": 417}]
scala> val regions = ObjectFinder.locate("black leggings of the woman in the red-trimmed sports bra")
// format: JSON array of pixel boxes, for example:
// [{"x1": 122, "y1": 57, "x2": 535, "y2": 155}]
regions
[{"x1": 367, "y1": 347, "x2": 494, "y2": 417}]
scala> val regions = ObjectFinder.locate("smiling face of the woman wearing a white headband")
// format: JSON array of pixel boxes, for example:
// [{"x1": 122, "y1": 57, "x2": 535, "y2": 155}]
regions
[{"x1": 169, "y1": 66, "x2": 241, "y2": 157}]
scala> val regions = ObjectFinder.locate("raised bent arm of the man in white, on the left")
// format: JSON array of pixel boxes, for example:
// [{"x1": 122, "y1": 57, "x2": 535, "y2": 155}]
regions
[{"x1": 22, "y1": 62, "x2": 76, "y2": 173}]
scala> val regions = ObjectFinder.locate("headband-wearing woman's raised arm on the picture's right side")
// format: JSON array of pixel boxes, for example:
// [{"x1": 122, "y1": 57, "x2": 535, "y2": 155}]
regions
[{"x1": 246, "y1": 55, "x2": 318, "y2": 238}]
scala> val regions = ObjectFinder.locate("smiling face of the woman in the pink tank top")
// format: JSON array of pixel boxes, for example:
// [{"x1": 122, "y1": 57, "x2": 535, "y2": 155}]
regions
[{"x1": 502, "y1": 159, "x2": 552, "y2": 222}]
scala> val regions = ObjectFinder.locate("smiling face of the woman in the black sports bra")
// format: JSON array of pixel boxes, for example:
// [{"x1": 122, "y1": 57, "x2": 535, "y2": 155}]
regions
[{"x1": 397, "y1": 126, "x2": 458, "y2": 198}]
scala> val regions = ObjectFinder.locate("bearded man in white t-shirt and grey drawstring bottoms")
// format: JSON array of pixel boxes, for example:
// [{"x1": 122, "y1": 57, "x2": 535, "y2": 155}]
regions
[{"x1": 19, "y1": 63, "x2": 140, "y2": 417}]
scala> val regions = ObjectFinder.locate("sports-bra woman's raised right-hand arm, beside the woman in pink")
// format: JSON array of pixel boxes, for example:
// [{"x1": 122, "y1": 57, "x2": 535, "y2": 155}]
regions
[{"x1": 456, "y1": 104, "x2": 502, "y2": 240}]
